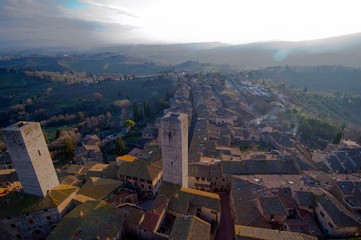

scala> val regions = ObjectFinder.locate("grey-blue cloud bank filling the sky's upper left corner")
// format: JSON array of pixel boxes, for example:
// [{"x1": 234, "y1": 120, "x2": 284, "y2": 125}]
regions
[{"x1": 0, "y1": 0, "x2": 139, "y2": 48}]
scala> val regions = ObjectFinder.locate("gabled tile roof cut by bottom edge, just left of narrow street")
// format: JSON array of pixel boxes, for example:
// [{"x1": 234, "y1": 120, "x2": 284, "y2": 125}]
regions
[{"x1": 169, "y1": 216, "x2": 211, "y2": 240}]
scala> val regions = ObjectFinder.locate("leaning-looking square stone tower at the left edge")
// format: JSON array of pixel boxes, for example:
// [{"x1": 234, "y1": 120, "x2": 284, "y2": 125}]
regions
[{"x1": 3, "y1": 122, "x2": 59, "y2": 197}]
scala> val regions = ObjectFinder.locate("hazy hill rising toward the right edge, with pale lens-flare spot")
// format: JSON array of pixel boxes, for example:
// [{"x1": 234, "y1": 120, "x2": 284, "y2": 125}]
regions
[{"x1": 194, "y1": 33, "x2": 361, "y2": 68}]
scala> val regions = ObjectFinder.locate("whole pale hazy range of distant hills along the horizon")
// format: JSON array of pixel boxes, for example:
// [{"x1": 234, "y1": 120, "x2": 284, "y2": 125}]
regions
[{"x1": 90, "y1": 33, "x2": 361, "y2": 68}]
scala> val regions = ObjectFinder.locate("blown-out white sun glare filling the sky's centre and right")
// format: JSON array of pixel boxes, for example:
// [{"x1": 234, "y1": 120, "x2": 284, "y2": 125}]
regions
[{"x1": 123, "y1": 0, "x2": 361, "y2": 43}]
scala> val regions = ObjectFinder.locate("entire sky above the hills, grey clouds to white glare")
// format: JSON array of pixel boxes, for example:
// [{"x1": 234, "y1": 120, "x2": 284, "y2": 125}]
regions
[{"x1": 0, "y1": 0, "x2": 361, "y2": 47}]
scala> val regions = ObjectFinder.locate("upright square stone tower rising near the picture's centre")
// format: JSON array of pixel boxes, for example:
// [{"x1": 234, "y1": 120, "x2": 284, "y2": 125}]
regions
[{"x1": 160, "y1": 112, "x2": 188, "y2": 187}]
